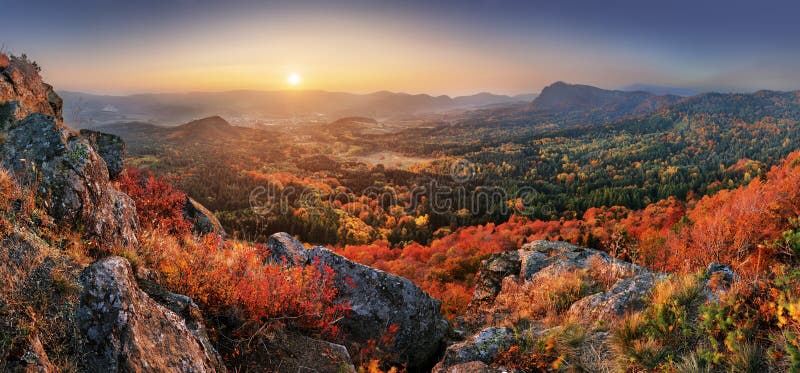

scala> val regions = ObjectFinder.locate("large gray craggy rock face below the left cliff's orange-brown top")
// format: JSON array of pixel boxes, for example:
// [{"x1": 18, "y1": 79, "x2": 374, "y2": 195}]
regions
[{"x1": 1, "y1": 114, "x2": 138, "y2": 246}]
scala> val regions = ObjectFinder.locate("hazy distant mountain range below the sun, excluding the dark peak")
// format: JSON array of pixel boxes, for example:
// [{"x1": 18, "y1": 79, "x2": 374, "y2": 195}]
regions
[{"x1": 59, "y1": 91, "x2": 536, "y2": 128}]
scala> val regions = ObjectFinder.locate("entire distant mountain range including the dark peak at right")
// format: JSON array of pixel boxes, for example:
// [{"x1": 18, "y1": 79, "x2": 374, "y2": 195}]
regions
[{"x1": 65, "y1": 82, "x2": 708, "y2": 128}]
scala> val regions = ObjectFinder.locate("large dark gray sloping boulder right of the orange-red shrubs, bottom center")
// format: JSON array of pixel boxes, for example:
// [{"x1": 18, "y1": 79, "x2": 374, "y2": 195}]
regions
[{"x1": 267, "y1": 235, "x2": 449, "y2": 370}]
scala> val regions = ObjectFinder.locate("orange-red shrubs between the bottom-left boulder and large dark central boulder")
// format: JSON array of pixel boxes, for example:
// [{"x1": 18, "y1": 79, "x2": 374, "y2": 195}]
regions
[{"x1": 140, "y1": 230, "x2": 350, "y2": 336}]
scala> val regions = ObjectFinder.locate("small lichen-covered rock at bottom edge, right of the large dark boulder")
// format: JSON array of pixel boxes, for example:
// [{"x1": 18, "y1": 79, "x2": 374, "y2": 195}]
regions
[{"x1": 433, "y1": 327, "x2": 515, "y2": 373}]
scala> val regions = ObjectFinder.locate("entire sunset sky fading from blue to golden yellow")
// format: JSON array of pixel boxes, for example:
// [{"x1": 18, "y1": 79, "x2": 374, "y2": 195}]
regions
[{"x1": 0, "y1": 0, "x2": 800, "y2": 95}]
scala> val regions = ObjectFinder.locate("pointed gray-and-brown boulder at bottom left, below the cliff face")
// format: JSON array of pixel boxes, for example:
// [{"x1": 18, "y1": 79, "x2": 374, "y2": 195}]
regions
[{"x1": 77, "y1": 257, "x2": 225, "y2": 372}]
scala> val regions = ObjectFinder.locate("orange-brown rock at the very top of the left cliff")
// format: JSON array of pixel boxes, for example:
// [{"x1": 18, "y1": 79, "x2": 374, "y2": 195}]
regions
[{"x1": 0, "y1": 54, "x2": 64, "y2": 121}]
